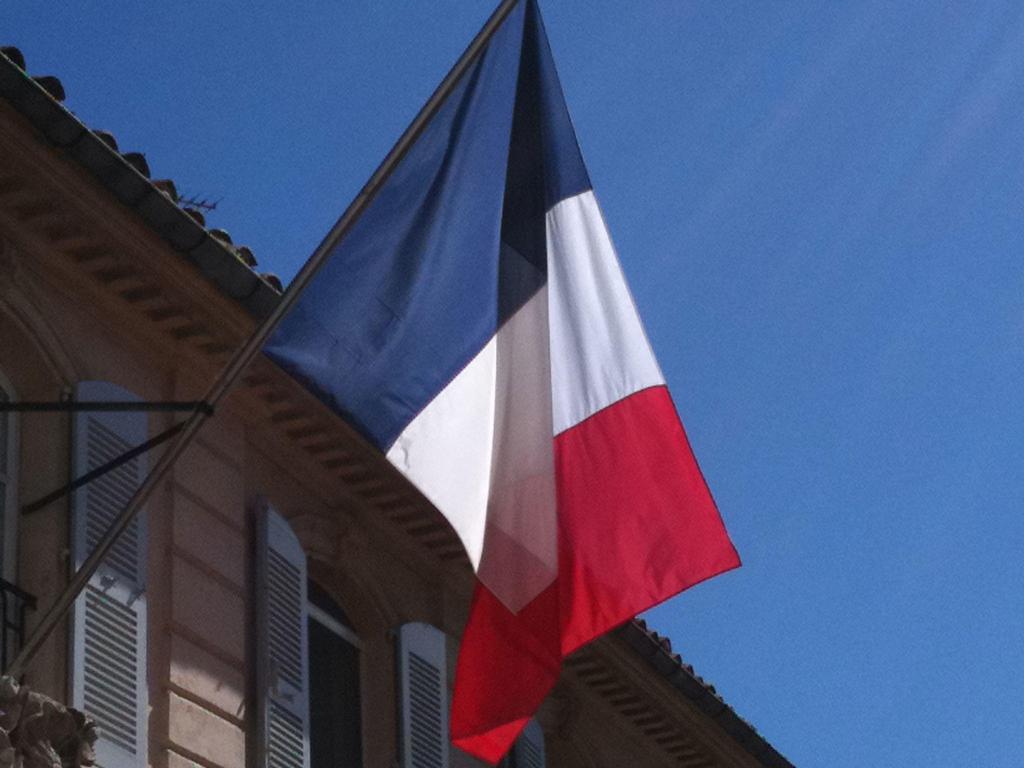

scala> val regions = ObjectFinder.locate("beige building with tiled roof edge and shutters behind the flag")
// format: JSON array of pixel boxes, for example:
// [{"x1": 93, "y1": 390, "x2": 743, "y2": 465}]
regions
[{"x1": 0, "y1": 48, "x2": 788, "y2": 768}]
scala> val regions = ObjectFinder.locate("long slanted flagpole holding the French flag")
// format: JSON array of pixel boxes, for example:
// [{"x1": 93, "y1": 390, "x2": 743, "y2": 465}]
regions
[{"x1": 4, "y1": 0, "x2": 519, "y2": 678}]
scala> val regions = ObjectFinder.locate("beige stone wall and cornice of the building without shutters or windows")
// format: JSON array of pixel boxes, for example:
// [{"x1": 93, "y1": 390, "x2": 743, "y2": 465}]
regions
[{"x1": 0, "y1": 104, "x2": 765, "y2": 768}]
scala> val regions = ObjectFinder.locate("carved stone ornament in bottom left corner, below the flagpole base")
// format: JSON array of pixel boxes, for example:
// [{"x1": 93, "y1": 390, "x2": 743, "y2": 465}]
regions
[{"x1": 0, "y1": 677, "x2": 96, "y2": 768}]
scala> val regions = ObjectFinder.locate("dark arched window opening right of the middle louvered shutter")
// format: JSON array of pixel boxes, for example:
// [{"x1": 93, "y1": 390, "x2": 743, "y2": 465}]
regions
[{"x1": 306, "y1": 581, "x2": 362, "y2": 768}]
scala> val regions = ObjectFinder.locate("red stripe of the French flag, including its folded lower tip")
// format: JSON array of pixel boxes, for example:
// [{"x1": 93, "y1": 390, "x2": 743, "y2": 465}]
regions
[{"x1": 452, "y1": 386, "x2": 739, "y2": 762}]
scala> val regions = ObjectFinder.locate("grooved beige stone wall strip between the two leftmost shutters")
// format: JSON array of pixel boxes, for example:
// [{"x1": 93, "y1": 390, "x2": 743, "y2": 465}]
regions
[{"x1": 157, "y1": 411, "x2": 250, "y2": 768}]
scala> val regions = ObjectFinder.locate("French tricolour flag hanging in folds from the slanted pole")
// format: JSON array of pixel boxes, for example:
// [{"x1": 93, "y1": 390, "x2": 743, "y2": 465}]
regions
[{"x1": 265, "y1": 0, "x2": 739, "y2": 763}]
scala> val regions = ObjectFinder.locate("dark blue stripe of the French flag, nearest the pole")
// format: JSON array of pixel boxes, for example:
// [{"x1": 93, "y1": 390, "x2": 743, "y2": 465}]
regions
[{"x1": 264, "y1": 0, "x2": 590, "y2": 452}]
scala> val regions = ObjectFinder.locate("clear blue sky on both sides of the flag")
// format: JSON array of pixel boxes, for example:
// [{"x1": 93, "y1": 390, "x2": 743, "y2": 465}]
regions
[{"x1": 8, "y1": 0, "x2": 1024, "y2": 766}]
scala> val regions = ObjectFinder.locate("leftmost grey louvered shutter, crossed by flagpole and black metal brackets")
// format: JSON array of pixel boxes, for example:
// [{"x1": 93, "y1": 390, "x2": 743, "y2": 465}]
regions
[{"x1": 72, "y1": 382, "x2": 148, "y2": 768}]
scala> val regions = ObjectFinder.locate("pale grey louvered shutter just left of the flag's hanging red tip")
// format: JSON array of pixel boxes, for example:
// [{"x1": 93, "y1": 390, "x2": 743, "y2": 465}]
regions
[{"x1": 398, "y1": 624, "x2": 449, "y2": 768}]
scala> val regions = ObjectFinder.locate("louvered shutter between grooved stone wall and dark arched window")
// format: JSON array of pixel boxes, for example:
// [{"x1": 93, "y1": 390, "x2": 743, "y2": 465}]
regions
[{"x1": 256, "y1": 507, "x2": 309, "y2": 768}]
